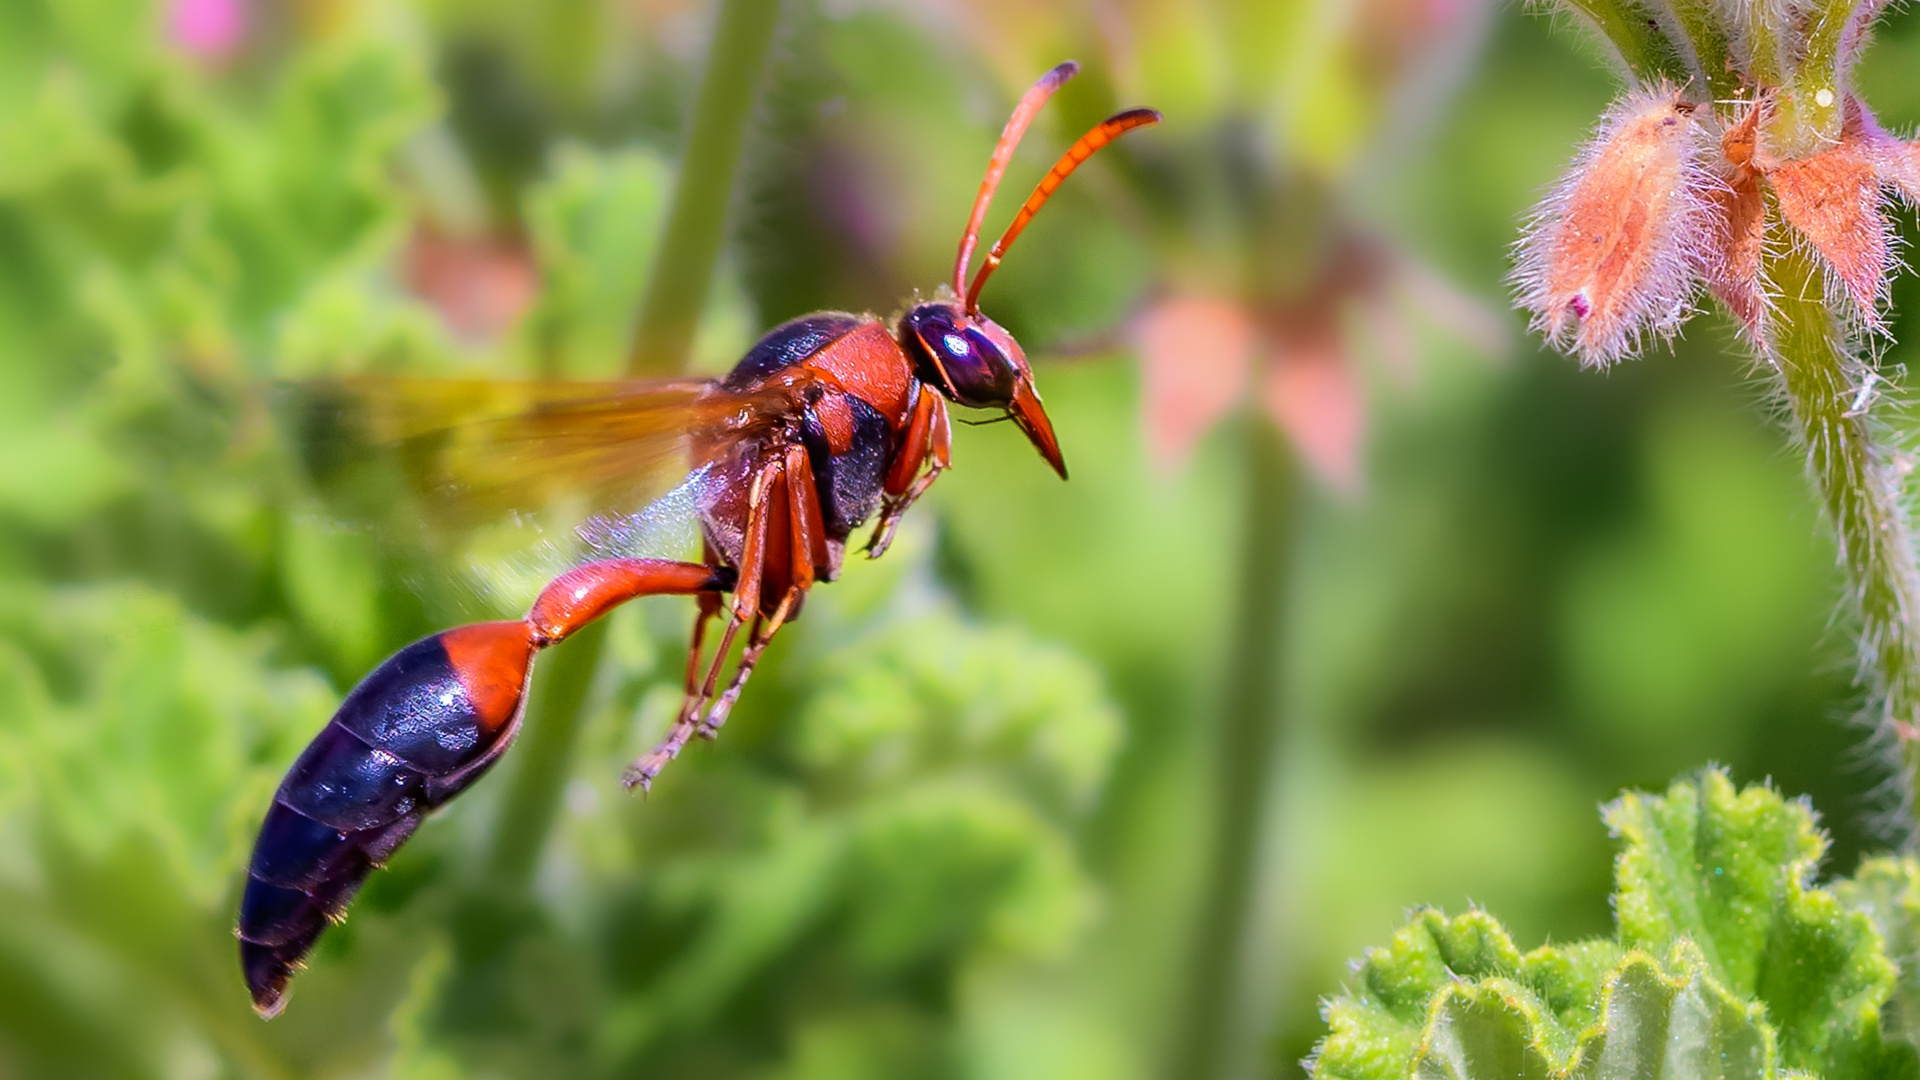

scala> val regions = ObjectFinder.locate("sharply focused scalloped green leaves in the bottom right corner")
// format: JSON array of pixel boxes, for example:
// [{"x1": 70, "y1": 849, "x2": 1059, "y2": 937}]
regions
[{"x1": 1311, "y1": 771, "x2": 1920, "y2": 1080}]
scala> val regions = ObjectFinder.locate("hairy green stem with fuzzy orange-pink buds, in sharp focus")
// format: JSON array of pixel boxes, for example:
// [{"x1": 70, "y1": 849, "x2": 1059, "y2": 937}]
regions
[{"x1": 1515, "y1": 0, "x2": 1920, "y2": 817}]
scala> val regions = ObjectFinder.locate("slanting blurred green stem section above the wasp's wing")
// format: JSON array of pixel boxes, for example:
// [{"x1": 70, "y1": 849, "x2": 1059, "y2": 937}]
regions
[{"x1": 626, "y1": 0, "x2": 780, "y2": 375}]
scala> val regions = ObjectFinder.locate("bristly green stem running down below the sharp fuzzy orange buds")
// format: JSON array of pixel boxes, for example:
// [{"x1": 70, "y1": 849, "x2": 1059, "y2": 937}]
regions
[{"x1": 1766, "y1": 242, "x2": 1920, "y2": 840}]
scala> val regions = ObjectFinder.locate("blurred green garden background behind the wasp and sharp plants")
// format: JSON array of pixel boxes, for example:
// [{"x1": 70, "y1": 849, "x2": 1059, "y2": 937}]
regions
[{"x1": 0, "y1": 0, "x2": 1920, "y2": 1080}]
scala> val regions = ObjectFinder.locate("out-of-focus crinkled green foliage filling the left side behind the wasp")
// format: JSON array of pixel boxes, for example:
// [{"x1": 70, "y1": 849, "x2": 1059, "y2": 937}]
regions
[{"x1": 0, "y1": 2, "x2": 1119, "y2": 1076}]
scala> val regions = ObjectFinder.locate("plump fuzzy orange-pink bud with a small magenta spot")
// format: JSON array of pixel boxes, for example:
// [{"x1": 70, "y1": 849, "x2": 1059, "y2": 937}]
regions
[{"x1": 1513, "y1": 88, "x2": 1722, "y2": 365}]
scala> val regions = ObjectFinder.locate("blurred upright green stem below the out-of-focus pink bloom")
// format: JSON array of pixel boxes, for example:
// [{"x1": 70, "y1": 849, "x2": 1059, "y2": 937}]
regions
[{"x1": 1171, "y1": 413, "x2": 1300, "y2": 1080}]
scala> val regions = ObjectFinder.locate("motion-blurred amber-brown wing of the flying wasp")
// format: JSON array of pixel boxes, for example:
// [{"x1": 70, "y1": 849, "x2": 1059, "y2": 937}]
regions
[{"x1": 280, "y1": 375, "x2": 783, "y2": 532}]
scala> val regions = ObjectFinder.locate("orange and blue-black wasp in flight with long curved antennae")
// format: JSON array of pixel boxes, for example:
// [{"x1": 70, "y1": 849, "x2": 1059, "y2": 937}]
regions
[{"x1": 238, "y1": 61, "x2": 1160, "y2": 1017}]
